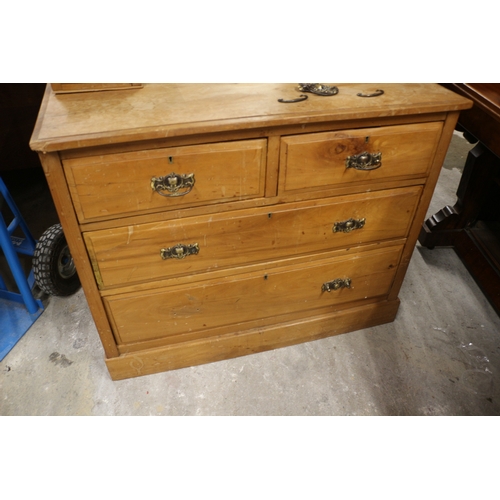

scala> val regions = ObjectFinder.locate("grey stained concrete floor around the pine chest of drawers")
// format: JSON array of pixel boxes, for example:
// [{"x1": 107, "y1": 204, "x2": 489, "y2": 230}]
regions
[{"x1": 0, "y1": 135, "x2": 500, "y2": 415}]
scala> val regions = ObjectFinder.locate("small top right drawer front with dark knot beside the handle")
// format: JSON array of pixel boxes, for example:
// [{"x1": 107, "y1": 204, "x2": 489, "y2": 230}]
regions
[{"x1": 280, "y1": 122, "x2": 442, "y2": 192}]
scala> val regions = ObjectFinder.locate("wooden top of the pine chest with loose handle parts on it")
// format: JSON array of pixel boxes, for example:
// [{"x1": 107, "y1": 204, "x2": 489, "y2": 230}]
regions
[{"x1": 30, "y1": 83, "x2": 470, "y2": 152}]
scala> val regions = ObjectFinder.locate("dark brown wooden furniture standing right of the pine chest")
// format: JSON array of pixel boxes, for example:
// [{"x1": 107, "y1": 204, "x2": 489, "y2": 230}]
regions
[{"x1": 419, "y1": 83, "x2": 500, "y2": 314}]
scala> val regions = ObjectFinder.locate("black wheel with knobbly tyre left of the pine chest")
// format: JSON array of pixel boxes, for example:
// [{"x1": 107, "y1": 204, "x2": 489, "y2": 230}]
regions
[{"x1": 33, "y1": 224, "x2": 80, "y2": 296}]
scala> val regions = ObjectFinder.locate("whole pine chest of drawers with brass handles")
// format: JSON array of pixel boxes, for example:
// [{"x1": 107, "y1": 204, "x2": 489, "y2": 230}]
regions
[{"x1": 30, "y1": 84, "x2": 470, "y2": 380}]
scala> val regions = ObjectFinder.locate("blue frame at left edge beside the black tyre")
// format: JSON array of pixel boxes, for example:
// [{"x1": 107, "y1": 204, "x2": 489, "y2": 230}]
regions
[{"x1": 0, "y1": 177, "x2": 44, "y2": 361}]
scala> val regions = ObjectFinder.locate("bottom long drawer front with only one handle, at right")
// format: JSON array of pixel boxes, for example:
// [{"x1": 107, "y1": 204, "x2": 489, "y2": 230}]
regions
[{"x1": 104, "y1": 246, "x2": 402, "y2": 343}]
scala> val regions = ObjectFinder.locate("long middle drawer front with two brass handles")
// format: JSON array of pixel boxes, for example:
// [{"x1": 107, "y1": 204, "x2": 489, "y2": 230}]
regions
[{"x1": 84, "y1": 186, "x2": 421, "y2": 288}]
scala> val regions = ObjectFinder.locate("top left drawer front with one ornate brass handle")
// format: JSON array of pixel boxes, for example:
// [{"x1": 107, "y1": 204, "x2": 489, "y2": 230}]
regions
[{"x1": 63, "y1": 139, "x2": 267, "y2": 222}]
